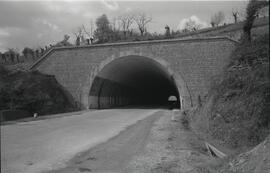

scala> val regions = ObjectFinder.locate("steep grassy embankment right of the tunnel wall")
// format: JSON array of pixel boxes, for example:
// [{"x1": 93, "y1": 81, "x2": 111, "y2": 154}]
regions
[{"x1": 190, "y1": 34, "x2": 270, "y2": 151}]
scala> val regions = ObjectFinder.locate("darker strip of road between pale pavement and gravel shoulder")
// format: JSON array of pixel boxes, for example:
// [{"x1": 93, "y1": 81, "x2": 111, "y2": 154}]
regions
[{"x1": 48, "y1": 111, "x2": 163, "y2": 173}]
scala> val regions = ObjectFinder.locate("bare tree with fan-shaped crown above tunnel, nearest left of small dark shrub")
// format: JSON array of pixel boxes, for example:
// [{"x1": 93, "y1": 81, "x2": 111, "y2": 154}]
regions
[{"x1": 134, "y1": 13, "x2": 152, "y2": 36}]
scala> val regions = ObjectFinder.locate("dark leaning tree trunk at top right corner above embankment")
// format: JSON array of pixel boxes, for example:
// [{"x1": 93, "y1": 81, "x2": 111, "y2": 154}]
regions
[{"x1": 243, "y1": 0, "x2": 269, "y2": 42}]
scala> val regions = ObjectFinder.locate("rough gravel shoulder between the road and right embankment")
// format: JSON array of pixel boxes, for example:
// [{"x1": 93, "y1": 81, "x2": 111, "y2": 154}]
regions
[{"x1": 126, "y1": 111, "x2": 217, "y2": 173}]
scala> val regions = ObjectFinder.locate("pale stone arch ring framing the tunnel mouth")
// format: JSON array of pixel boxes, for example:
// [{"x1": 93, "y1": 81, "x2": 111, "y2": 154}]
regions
[{"x1": 87, "y1": 51, "x2": 193, "y2": 109}]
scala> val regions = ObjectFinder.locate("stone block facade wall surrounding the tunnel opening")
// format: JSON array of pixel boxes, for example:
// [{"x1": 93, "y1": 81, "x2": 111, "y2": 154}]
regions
[{"x1": 31, "y1": 38, "x2": 237, "y2": 108}]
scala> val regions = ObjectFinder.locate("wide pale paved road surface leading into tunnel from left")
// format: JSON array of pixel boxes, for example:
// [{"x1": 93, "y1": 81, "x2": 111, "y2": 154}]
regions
[{"x1": 1, "y1": 109, "x2": 158, "y2": 173}]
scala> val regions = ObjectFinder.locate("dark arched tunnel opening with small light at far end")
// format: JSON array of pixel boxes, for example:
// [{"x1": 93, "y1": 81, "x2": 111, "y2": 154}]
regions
[{"x1": 89, "y1": 56, "x2": 181, "y2": 109}]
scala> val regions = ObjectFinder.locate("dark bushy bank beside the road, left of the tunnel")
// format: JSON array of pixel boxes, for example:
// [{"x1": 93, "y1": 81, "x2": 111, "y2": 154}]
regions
[{"x1": 0, "y1": 66, "x2": 75, "y2": 115}]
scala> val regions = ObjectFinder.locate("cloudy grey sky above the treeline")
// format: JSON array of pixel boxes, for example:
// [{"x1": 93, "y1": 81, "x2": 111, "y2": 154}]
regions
[{"x1": 0, "y1": 0, "x2": 247, "y2": 52}]
